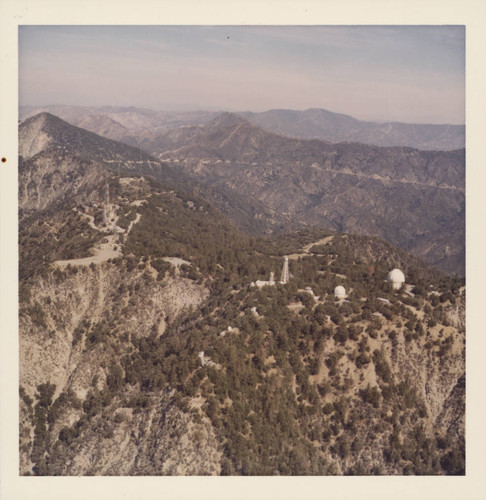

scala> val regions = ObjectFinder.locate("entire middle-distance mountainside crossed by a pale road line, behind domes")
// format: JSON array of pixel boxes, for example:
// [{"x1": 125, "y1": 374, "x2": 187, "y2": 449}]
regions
[{"x1": 149, "y1": 113, "x2": 465, "y2": 274}]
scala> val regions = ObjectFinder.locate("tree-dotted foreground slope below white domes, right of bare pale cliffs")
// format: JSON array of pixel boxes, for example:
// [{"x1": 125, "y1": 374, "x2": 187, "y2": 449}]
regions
[{"x1": 169, "y1": 287, "x2": 463, "y2": 475}]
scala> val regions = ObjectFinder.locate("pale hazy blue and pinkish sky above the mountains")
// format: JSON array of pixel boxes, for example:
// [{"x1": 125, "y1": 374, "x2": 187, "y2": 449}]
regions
[{"x1": 19, "y1": 26, "x2": 465, "y2": 124}]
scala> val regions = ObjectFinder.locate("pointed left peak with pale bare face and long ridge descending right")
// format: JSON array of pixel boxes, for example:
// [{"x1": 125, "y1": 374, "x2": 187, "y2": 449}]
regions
[{"x1": 19, "y1": 112, "x2": 289, "y2": 233}]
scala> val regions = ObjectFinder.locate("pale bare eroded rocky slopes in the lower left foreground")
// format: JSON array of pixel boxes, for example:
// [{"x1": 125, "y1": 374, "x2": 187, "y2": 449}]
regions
[{"x1": 20, "y1": 252, "x2": 221, "y2": 475}]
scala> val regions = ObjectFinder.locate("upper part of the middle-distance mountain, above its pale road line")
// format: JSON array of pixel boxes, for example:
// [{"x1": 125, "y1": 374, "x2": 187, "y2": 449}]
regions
[{"x1": 155, "y1": 113, "x2": 464, "y2": 190}]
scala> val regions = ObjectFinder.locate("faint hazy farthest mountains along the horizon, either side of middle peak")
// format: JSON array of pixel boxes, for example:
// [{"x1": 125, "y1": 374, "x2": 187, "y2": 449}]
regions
[{"x1": 19, "y1": 105, "x2": 465, "y2": 151}]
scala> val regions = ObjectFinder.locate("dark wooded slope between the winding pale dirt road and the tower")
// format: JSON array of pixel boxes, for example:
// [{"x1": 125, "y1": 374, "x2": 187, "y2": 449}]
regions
[{"x1": 120, "y1": 178, "x2": 281, "y2": 284}]
